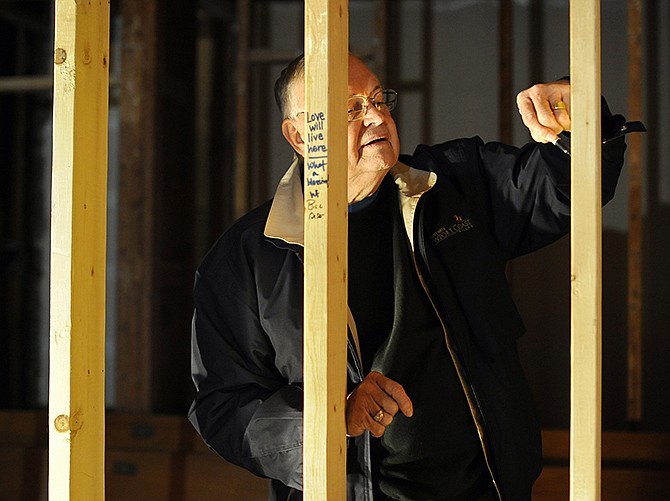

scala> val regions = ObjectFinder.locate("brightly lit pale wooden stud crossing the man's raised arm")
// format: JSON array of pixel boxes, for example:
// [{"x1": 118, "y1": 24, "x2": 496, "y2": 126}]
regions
[{"x1": 570, "y1": 0, "x2": 602, "y2": 501}]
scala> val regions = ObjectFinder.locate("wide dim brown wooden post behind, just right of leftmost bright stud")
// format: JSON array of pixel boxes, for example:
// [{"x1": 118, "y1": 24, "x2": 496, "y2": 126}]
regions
[{"x1": 116, "y1": 0, "x2": 158, "y2": 412}]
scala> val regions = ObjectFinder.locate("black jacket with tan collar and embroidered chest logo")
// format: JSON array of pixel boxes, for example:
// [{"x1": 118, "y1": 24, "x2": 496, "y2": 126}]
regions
[{"x1": 189, "y1": 130, "x2": 625, "y2": 501}]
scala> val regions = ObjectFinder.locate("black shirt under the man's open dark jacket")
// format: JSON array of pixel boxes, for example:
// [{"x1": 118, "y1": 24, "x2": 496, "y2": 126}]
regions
[{"x1": 349, "y1": 176, "x2": 490, "y2": 500}]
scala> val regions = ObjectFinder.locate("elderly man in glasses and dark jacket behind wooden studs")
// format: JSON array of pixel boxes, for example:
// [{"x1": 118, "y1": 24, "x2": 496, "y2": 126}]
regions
[{"x1": 189, "y1": 52, "x2": 636, "y2": 501}]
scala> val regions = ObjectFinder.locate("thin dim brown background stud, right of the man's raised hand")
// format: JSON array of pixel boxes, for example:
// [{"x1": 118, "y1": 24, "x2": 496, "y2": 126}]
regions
[{"x1": 627, "y1": 0, "x2": 643, "y2": 428}]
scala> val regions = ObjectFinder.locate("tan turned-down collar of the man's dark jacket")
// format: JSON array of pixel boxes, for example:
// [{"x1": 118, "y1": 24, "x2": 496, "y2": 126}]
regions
[{"x1": 264, "y1": 157, "x2": 437, "y2": 245}]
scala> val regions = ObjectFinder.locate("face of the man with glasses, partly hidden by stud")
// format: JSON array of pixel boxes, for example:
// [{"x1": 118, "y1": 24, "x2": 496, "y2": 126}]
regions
[{"x1": 293, "y1": 56, "x2": 400, "y2": 179}]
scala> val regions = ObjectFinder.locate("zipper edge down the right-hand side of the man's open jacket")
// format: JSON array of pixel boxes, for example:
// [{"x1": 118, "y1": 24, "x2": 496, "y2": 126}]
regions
[{"x1": 412, "y1": 194, "x2": 502, "y2": 501}]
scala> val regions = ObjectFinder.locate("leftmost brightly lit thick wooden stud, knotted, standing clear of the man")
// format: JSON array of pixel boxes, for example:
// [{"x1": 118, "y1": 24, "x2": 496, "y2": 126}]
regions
[{"x1": 49, "y1": 0, "x2": 109, "y2": 500}]
